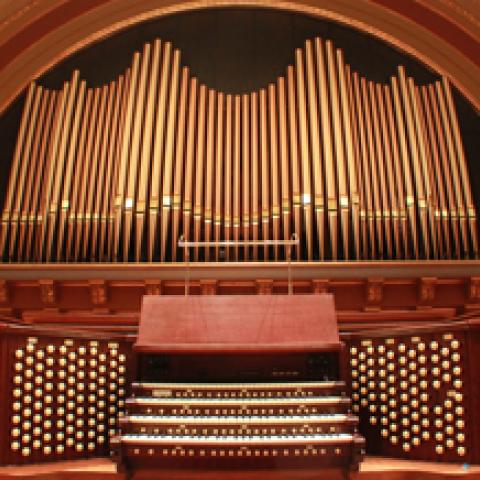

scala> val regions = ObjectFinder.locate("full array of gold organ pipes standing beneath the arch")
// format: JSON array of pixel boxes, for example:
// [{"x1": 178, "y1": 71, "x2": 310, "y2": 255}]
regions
[{"x1": 0, "y1": 38, "x2": 478, "y2": 262}]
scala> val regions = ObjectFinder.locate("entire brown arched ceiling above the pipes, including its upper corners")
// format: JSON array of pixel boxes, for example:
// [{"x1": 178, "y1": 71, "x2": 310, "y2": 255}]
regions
[{"x1": 0, "y1": 0, "x2": 480, "y2": 113}]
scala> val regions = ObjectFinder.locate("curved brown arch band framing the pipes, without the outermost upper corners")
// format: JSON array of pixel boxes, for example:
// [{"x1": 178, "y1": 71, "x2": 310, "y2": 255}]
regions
[{"x1": 0, "y1": 0, "x2": 480, "y2": 113}]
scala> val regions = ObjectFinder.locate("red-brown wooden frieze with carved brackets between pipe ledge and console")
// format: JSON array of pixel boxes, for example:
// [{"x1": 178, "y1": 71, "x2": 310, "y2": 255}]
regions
[{"x1": 0, "y1": 272, "x2": 480, "y2": 318}]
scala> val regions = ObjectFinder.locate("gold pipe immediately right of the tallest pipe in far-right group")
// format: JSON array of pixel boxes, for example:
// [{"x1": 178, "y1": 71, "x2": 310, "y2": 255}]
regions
[{"x1": 408, "y1": 85, "x2": 441, "y2": 258}]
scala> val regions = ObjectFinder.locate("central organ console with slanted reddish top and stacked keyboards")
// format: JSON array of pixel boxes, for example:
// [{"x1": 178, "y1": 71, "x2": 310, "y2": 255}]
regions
[{"x1": 111, "y1": 295, "x2": 364, "y2": 478}]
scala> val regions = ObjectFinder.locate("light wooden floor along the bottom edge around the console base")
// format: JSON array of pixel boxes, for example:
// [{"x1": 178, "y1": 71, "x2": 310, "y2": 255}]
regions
[{"x1": 0, "y1": 457, "x2": 480, "y2": 480}]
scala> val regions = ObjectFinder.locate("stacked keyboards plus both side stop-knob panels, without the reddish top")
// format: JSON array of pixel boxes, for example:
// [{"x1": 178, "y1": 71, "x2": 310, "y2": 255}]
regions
[{"x1": 0, "y1": 296, "x2": 480, "y2": 468}]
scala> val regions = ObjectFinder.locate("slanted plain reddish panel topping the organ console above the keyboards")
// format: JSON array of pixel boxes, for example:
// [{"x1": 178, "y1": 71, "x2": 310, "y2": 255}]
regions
[{"x1": 135, "y1": 295, "x2": 340, "y2": 353}]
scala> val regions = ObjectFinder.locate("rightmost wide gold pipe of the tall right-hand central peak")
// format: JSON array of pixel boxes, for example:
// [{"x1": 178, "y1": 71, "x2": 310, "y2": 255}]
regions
[{"x1": 336, "y1": 49, "x2": 360, "y2": 259}]
